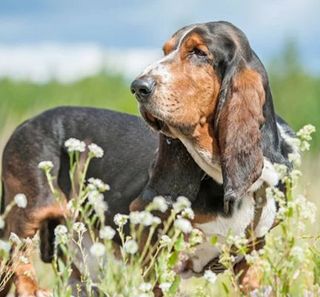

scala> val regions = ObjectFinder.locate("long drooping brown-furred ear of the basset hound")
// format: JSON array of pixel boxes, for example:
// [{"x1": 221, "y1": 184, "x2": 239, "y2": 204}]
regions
[{"x1": 218, "y1": 68, "x2": 265, "y2": 206}]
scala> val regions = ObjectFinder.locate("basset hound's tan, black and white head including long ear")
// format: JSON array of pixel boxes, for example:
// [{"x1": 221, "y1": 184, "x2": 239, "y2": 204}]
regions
[{"x1": 131, "y1": 22, "x2": 268, "y2": 204}]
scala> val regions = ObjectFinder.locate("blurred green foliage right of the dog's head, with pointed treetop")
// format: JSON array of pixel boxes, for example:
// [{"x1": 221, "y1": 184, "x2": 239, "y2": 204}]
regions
[{"x1": 268, "y1": 40, "x2": 320, "y2": 152}]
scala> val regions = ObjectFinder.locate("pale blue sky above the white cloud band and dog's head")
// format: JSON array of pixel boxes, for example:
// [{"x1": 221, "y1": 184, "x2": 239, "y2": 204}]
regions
[{"x1": 0, "y1": 0, "x2": 320, "y2": 73}]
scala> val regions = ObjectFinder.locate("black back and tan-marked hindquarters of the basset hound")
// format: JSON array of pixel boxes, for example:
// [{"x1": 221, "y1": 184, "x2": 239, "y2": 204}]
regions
[{"x1": 1, "y1": 107, "x2": 157, "y2": 243}]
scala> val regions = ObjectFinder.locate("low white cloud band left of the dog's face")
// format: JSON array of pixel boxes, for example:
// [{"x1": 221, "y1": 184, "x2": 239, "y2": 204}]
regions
[{"x1": 0, "y1": 44, "x2": 161, "y2": 83}]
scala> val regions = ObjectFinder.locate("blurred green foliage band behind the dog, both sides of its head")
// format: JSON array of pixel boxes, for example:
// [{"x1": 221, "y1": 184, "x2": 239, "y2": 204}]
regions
[{"x1": 0, "y1": 42, "x2": 320, "y2": 150}]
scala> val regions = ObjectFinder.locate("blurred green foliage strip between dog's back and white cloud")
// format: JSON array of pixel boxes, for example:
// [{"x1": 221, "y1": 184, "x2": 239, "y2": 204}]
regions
[{"x1": 0, "y1": 73, "x2": 137, "y2": 128}]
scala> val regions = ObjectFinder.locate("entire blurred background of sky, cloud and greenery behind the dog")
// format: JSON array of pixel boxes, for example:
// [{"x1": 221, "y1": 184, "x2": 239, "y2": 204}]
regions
[{"x1": 0, "y1": 0, "x2": 320, "y2": 292}]
